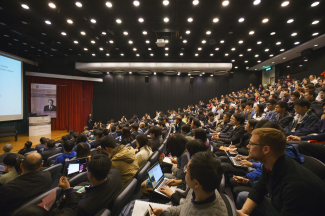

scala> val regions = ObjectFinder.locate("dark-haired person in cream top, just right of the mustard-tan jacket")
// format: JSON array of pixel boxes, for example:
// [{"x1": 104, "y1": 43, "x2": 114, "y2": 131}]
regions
[{"x1": 136, "y1": 133, "x2": 152, "y2": 167}]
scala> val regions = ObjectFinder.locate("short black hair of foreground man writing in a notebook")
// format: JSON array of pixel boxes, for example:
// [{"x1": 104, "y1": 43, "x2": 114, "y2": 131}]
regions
[{"x1": 188, "y1": 151, "x2": 223, "y2": 192}]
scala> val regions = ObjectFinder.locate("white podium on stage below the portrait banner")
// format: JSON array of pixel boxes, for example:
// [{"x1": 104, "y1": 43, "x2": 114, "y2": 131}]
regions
[{"x1": 29, "y1": 116, "x2": 51, "y2": 136}]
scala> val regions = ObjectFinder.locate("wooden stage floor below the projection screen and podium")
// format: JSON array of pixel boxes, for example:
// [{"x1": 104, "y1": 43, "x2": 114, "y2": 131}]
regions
[{"x1": 0, "y1": 130, "x2": 69, "y2": 154}]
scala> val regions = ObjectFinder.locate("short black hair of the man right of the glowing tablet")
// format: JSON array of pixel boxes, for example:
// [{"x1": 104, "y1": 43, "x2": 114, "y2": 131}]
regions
[{"x1": 87, "y1": 154, "x2": 112, "y2": 181}]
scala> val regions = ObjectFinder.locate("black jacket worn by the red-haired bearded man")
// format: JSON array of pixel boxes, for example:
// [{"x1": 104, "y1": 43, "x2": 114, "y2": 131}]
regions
[{"x1": 248, "y1": 155, "x2": 325, "y2": 216}]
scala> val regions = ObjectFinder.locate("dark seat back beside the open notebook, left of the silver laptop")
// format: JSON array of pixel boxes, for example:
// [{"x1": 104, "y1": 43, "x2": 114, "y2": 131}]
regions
[{"x1": 110, "y1": 178, "x2": 137, "y2": 216}]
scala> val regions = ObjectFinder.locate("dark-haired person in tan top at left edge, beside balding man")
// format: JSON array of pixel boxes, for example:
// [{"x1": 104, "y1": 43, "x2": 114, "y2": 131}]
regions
[{"x1": 0, "y1": 153, "x2": 22, "y2": 187}]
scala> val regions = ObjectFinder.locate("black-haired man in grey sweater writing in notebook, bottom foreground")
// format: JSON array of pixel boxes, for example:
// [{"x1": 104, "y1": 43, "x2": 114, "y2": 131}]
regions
[{"x1": 151, "y1": 151, "x2": 228, "y2": 216}]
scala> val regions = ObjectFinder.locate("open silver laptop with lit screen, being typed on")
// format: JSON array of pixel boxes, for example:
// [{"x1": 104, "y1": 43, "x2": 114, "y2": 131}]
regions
[{"x1": 148, "y1": 162, "x2": 177, "y2": 198}]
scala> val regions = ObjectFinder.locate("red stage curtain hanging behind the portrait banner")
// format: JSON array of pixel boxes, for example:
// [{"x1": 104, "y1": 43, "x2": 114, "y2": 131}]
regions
[{"x1": 27, "y1": 77, "x2": 93, "y2": 132}]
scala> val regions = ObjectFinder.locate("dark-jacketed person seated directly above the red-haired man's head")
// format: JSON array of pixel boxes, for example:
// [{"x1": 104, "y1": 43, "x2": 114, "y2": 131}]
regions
[{"x1": 273, "y1": 101, "x2": 293, "y2": 128}]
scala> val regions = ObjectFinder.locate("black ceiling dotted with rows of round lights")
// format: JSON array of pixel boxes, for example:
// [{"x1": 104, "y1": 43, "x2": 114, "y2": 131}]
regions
[{"x1": 0, "y1": 0, "x2": 325, "y2": 70}]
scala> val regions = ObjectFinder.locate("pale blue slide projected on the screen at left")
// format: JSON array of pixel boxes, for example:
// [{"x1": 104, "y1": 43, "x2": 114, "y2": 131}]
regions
[{"x1": 0, "y1": 55, "x2": 23, "y2": 121}]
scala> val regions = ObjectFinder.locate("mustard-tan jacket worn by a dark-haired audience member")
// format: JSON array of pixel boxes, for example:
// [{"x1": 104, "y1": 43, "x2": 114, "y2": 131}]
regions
[{"x1": 109, "y1": 145, "x2": 139, "y2": 187}]
